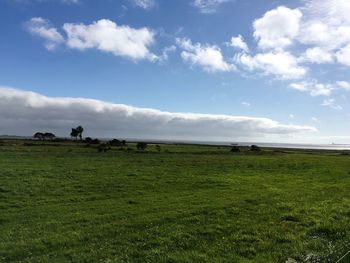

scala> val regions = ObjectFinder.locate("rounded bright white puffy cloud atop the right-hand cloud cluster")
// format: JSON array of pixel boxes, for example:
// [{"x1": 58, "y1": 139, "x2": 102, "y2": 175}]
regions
[{"x1": 253, "y1": 6, "x2": 302, "y2": 50}]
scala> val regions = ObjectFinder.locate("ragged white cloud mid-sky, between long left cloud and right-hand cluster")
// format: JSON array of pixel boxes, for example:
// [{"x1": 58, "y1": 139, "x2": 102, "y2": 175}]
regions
[{"x1": 176, "y1": 38, "x2": 236, "y2": 72}]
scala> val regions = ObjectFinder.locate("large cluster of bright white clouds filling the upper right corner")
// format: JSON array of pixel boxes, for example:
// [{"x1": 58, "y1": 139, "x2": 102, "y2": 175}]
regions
[{"x1": 231, "y1": 0, "x2": 350, "y2": 99}]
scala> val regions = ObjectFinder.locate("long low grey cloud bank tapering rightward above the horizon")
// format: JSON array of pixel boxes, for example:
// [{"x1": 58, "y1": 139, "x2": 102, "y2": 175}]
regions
[{"x1": 0, "y1": 87, "x2": 316, "y2": 140}]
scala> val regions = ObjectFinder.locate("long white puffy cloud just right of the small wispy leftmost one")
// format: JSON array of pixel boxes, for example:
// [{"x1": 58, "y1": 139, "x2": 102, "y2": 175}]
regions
[{"x1": 63, "y1": 19, "x2": 157, "y2": 61}]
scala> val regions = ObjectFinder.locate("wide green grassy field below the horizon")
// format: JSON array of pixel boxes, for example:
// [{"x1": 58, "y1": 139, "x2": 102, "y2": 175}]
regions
[{"x1": 0, "y1": 140, "x2": 350, "y2": 262}]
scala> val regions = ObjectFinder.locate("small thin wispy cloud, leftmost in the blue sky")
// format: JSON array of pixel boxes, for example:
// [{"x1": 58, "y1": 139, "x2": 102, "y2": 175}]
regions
[{"x1": 25, "y1": 17, "x2": 64, "y2": 50}]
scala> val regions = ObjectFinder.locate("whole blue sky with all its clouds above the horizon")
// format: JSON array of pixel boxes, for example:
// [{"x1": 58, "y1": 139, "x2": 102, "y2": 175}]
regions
[{"x1": 0, "y1": 0, "x2": 350, "y2": 143}]
